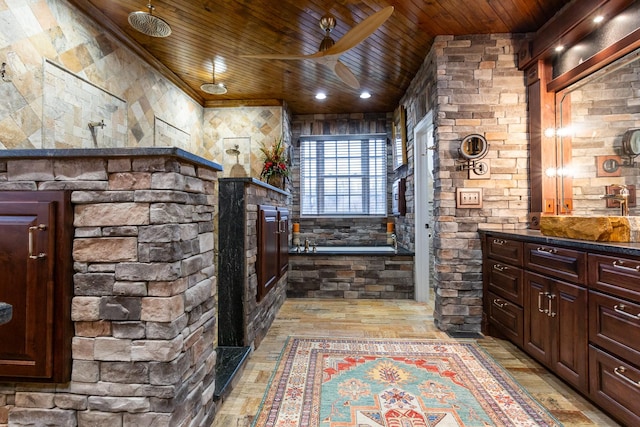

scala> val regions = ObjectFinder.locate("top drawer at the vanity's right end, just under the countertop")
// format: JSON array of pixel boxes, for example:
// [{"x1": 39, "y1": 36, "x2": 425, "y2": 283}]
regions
[{"x1": 589, "y1": 254, "x2": 640, "y2": 302}]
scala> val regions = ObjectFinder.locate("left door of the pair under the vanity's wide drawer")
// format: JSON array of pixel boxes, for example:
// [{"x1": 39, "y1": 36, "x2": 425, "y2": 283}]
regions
[{"x1": 523, "y1": 271, "x2": 552, "y2": 366}]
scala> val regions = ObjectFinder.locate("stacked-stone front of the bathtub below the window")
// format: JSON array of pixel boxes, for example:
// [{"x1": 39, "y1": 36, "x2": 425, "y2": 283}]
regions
[{"x1": 287, "y1": 254, "x2": 414, "y2": 299}]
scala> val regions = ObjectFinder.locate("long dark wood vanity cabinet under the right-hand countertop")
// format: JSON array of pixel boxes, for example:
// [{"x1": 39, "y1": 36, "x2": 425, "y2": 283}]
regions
[{"x1": 483, "y1": 232, "x2": 640, "y2": 426}]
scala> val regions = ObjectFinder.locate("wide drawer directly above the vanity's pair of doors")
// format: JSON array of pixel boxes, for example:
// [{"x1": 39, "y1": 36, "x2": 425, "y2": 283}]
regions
[{"x1": 524, "y1": 243, "x2": 587, "y2": 285}]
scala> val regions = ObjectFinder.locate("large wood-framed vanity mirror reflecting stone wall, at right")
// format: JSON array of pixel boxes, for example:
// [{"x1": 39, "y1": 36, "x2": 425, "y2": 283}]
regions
[{"x1": 556, "y1": 50, "x2": 640, "y2": 215}]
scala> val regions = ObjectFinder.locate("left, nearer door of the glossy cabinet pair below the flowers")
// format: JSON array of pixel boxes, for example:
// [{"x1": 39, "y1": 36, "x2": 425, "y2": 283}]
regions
[{"x1": 257, "y1": 205, "x2": 279, "y2": 301}]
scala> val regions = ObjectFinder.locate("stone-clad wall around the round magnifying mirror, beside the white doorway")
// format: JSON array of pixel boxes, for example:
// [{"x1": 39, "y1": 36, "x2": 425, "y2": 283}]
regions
[{"x1": 401, "y1": 34, "x2": 529, "y2": 331}]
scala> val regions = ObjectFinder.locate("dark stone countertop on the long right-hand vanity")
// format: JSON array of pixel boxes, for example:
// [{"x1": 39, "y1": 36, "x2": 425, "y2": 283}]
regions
[{"x1": 479, "y1": 230, "x2": 640, "y2": 256}]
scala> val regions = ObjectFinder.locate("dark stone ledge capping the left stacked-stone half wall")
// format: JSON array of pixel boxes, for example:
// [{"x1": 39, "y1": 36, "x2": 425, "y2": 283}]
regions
[{"x1": 0, "y1": 147, "x2": 222, "y2": 171}]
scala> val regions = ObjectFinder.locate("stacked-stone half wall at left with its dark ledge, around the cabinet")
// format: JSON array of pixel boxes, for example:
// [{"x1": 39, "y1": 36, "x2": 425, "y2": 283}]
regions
[{"x1": 0, "y1": 148, "x2": 221, "y2": 427}]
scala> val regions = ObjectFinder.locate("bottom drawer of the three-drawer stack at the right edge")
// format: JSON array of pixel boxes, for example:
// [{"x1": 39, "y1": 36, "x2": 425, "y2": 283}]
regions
[{"x1": 589, "y1": 346, "x2": 640, "y2": 426}]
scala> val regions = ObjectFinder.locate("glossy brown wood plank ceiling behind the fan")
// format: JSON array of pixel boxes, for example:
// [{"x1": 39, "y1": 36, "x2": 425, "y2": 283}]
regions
[{"x1": 71, "y1": 0, "x2": 568, "y2": 114}]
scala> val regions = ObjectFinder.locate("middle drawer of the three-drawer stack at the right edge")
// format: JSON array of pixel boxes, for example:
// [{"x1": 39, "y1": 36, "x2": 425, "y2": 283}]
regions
[{"x1": 589, "y1": 291, "x2": 640, "y2": 366}]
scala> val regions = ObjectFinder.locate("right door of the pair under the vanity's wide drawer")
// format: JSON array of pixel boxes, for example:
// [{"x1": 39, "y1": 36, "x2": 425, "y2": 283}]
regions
[{"x1": 549, "y1": 280, "x2": 588, "y2": 392}]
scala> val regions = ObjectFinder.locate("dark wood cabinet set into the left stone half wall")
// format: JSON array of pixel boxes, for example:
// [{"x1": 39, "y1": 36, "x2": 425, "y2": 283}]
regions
[{"x1": 0, "y1": 191, "x2": 72, "y2": 382}]
